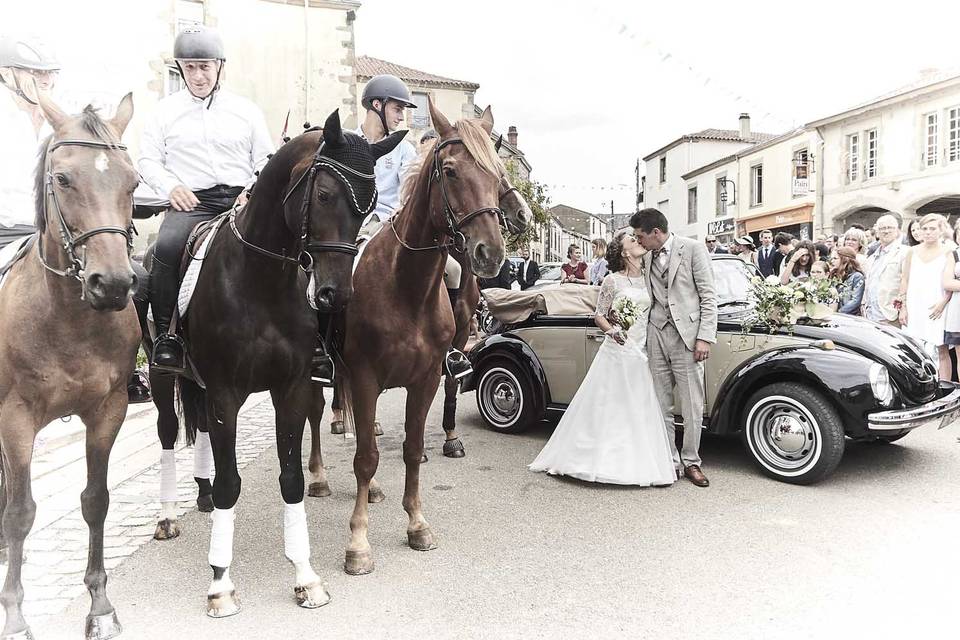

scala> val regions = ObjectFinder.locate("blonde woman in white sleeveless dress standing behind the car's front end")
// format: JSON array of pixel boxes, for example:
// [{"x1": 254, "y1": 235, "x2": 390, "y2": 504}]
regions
[{"x1": 900, "y1": 213, "x2": 952, "y2": 380}]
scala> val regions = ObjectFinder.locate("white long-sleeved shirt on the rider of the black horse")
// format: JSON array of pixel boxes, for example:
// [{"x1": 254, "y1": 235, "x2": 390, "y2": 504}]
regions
[{"x1": 138, "y1": 89, "x2": 274, "y2": 196}]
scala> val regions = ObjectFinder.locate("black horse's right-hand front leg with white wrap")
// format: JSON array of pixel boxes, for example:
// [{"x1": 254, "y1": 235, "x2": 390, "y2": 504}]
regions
[{"x1": 270, "y1": 380, "x2": 330, "y2": 609}]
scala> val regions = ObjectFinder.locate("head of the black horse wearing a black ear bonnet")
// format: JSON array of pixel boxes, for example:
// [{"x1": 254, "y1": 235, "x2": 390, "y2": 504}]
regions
[{"x1": 284, "y1": 110, "x2": 407, "y2": 312}]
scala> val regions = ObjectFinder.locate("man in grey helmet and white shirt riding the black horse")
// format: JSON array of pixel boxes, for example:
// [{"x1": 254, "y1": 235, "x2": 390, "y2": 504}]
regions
[{"x1": 139, "y1": 25, "x2": 274, "y2": 373}]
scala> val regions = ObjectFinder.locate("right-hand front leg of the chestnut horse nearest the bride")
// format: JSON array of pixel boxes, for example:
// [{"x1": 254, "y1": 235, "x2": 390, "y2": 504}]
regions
[{"x1": 403, "y1": 375, "x2": 440, "y2": 551}]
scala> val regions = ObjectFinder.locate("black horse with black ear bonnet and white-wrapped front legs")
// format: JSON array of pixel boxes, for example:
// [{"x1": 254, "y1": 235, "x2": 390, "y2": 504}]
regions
[{"x1": 179, "y1": 111, "x2": 407, "y2": 618}]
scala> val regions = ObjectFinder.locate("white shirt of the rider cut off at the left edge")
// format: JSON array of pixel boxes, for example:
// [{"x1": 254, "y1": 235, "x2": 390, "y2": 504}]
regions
[{"x1": 0, "y1": 89, "x2": 53, "y2": 227}]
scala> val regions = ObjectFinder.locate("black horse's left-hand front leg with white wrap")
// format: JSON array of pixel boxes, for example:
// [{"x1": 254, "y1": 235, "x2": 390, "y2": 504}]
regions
[{"x1": 207, "y1": 395, "x2": 240, "y2": 618}]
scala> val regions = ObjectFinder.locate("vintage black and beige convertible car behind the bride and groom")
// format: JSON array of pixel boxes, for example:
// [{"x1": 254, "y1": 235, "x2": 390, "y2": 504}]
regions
[{"x1": 461, "y1": 256, "x2": 960, "y2": 484}]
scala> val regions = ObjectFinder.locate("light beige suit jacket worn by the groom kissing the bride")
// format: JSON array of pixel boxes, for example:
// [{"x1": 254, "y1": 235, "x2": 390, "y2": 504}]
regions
[{"x1": 643, "y1": 235, "x2": 717, "y2": 351}]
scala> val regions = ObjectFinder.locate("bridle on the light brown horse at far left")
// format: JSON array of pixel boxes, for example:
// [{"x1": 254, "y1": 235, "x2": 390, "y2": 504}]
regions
[{"x1": 37, "y1": 140, "x2": 136, "y2": 282}]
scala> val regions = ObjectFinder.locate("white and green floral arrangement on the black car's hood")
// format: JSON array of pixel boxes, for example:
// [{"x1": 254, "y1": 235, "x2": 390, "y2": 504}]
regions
[{"x1": 744, "y1": 276, "x2": 839, "y2": 333}]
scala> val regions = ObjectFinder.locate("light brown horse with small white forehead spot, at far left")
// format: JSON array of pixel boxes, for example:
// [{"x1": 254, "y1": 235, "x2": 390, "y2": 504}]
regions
[{"x1": 0, "y1": 94, "x2": 140, "y2": 640}]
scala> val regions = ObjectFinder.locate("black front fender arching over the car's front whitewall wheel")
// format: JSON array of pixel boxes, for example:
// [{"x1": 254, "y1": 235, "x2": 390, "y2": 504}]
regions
[{"x1": 710, "y1": 345, "x2": 878, "y2": 436}]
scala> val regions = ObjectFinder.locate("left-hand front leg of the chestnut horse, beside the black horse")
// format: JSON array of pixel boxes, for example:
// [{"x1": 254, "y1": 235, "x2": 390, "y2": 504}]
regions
[{"x1": 343, "y1": 371, "x2": 380, "y2": 576}]
